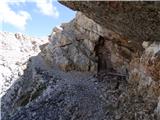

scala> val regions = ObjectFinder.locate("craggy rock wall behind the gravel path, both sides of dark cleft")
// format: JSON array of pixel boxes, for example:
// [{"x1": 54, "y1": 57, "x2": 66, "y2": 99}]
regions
[{"x1": 41, "y1": 12, "x2": 131, "y2": 71}]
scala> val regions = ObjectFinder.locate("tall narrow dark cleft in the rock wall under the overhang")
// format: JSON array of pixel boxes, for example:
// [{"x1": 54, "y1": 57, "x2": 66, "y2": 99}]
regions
[{"x1": 95, "y1": 36, "x2": 114, "y2": 73}]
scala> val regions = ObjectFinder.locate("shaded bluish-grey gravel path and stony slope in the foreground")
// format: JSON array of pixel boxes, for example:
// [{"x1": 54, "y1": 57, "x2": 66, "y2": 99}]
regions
[{"x1": 1, "y1": 54, "x2": 156, "y2": 120}]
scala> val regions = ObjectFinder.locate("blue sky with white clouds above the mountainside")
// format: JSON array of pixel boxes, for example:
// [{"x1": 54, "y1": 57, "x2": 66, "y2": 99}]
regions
[{"x1": 0, "y1": 0, "x2": 76, "y2": 37}]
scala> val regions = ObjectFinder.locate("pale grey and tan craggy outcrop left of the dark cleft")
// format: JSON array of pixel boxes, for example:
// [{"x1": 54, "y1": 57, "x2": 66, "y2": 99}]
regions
[{"x1": 42, "y1": 13, "x2": 99, "y2": 71}]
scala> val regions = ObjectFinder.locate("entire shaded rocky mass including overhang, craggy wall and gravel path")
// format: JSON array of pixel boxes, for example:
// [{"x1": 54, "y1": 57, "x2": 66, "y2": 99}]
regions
[{"x1": 2, "y1": 1, "x2": 160, "y2": 120}]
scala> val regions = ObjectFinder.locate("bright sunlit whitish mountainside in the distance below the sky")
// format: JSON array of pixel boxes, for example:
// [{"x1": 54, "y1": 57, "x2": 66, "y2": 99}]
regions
[{"x1": 0, "y1": 32, "x2": 47, "y2": 95}]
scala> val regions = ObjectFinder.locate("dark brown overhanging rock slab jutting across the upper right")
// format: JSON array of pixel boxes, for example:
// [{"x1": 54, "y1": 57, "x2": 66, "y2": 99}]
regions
[{"x1": 59, "y1": 1, "x2": 160, "y2": 42}]
